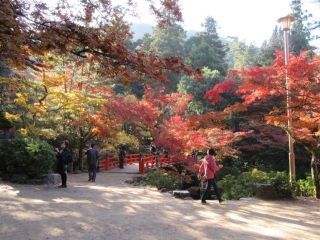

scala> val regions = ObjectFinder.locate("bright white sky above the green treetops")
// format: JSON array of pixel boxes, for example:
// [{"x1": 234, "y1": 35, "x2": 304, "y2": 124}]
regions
[{"x1": 125, "y1": 0, "x2": 320, "y2": 48}]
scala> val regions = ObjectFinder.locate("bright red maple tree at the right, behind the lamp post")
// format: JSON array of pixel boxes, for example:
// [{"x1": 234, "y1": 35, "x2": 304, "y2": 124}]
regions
[{"x1": 206, "y1": 52, "x2": 320, "y2": 198}]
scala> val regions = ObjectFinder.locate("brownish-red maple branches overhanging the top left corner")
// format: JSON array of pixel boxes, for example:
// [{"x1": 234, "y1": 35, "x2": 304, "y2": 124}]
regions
[{"x1": 0, "y1": 0, "x2": 200, "y2": 82}]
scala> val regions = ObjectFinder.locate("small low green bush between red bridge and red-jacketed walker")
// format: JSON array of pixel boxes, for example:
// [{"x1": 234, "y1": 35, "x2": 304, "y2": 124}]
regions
[{"x1": 146, "y1": 170, "x2": 181, "y2": 190}]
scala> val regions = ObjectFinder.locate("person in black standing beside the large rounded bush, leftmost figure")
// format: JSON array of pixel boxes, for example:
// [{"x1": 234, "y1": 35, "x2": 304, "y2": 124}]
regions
[{"x1": 56, "y1": 141, "x2": 72, "y2": 188}]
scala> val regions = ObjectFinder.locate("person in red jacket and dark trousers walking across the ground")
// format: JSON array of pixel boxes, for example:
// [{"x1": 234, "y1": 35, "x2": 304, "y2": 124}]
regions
[{"x1": 199, "y1": 148, "x2": 222, "y2": 204}]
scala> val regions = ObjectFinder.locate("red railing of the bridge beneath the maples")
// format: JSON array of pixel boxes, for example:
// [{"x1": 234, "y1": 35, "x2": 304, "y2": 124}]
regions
[{"x1": 99, "y1": 154, "x2": 196, "y2": 174}]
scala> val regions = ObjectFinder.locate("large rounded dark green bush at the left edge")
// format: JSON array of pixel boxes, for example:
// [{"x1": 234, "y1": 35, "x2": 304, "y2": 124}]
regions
[{"x1": 0, "y1": 138, "x2": 56, "y2": 178}]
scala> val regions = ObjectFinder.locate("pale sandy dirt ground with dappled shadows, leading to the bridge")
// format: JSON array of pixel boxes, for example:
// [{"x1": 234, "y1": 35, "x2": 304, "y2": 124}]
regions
[{"x1": 0, "y1": 166, "x2": 320, "y2": 240}]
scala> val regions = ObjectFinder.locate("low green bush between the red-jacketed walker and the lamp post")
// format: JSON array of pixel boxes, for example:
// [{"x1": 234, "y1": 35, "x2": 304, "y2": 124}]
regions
[{"x1": 219, "y1": 169, "x2": 293, "y2": 199}]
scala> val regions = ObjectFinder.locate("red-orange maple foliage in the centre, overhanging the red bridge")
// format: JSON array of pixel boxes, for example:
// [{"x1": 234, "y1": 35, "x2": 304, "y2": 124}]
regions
[{"x1": 103, "y1": 87, "x2": 241, "y2": 158}]
